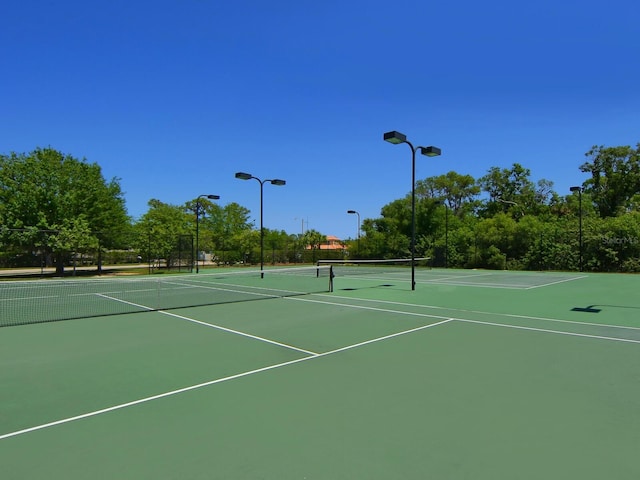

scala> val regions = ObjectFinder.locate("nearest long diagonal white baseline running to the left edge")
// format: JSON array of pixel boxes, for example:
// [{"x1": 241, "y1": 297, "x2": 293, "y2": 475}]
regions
[{"x1": 0, "y1": 319, "x2": 453, "y2": 440}]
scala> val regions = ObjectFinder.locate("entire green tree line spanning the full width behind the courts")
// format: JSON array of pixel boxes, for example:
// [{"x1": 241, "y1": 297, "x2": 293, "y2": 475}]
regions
[{"x1": 0, "y1": 144, "x2": 640, "y2": 274}]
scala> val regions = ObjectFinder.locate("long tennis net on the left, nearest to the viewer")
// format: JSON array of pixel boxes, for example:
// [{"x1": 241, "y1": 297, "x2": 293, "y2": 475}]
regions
[{"x1": 0, "y1": 265, "x2": 333, "y2": 327}]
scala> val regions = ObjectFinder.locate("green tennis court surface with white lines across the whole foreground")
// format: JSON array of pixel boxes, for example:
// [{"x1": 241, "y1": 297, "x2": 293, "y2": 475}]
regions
[{"x1": 0, "y1": 269, "x2": 640, "y2": 480}]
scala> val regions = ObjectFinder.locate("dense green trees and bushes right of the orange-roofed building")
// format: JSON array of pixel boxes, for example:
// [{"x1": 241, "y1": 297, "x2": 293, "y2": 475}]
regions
[{"x1": 357, "y1": 144, "x2": 640, "y2": 272}]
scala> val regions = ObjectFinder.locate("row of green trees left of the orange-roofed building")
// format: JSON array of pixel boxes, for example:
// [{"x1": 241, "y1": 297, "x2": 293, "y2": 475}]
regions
[{"x1": 0, "y1": 148, "x2": 325, "y2": 274}]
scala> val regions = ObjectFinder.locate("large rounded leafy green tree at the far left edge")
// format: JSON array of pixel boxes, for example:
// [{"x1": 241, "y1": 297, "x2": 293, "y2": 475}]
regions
[{"x1": 0, "y1": 148, "x2": 130, "y2": 274}]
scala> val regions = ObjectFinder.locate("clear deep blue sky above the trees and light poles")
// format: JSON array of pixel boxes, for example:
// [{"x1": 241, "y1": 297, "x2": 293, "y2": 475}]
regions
[{"x1": 0, "y1": 0, "x2": 640, "y2": 238}]
